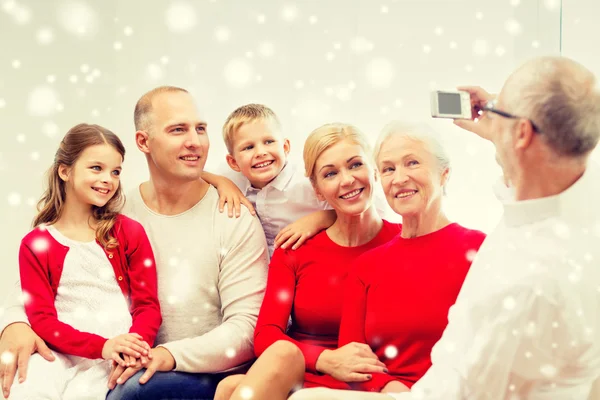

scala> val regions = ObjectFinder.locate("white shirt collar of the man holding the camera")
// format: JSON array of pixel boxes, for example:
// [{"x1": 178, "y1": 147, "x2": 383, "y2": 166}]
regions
[{"x1": 504, "y1": 163, "x2": 600, "y2": 226}]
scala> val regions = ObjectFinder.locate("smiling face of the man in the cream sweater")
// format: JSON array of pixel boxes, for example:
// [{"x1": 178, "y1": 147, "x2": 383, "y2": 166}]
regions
[{"x1": 136, "y1": 92, "x2": 210, "y2": 181}]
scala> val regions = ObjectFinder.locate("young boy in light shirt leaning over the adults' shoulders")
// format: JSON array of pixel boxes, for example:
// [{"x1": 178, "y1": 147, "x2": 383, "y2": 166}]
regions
[{"x1": 203, "y1": 104, "x2": 394, "y2": 255}]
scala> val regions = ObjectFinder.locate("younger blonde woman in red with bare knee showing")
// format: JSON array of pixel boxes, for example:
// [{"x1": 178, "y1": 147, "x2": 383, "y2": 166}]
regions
[{"x1": 215, "y1": 124, "x2": 400, "y2": 400}]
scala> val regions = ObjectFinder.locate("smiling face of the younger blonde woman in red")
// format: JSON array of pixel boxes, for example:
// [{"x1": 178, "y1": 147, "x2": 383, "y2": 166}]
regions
[{"x1": 313, "y1": 139, "x2": 375, "y2": 216}]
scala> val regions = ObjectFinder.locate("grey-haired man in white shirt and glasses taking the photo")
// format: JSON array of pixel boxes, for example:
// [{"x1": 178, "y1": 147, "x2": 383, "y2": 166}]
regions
[{"x1": 293, "y1": 57, "x2": 600, "y2": 400}]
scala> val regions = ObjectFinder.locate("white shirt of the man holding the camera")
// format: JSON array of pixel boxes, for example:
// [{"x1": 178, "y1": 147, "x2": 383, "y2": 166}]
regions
[{"x1": 396, "y1": 165, "x2": 600, "y2": 400}]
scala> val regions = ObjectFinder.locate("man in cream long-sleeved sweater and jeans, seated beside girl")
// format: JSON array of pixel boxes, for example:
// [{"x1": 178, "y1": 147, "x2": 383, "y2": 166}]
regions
[{"x1": 0, "y1": 87, "x2": 268, "y2": 400}]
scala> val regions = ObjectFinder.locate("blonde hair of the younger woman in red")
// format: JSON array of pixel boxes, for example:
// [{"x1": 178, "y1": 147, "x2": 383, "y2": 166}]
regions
[{"x1": 304, "y1": 123, "x2": 374, "y2": 184}]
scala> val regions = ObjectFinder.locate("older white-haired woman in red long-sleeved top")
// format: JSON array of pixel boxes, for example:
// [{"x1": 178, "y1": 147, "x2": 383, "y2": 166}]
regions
[{"x1": 292, "y1": 123, "x2": 485, "y2": 400}]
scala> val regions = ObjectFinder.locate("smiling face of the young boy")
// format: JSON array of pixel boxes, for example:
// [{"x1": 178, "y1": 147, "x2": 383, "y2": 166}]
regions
[{"x1": 227, "y1": 118, "x2": 290, "y2": 189}]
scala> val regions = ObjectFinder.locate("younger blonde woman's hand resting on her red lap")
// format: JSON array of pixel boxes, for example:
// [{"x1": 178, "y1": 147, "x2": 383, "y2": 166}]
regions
[{"x1": 316, "y1": 342, "x2": 387, "y2": 382}]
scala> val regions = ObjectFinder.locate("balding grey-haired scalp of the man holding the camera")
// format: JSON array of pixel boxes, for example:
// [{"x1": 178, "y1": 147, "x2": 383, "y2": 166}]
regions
[{"x1": 502, "y1": 57, "x2": 600, "y2": 157}]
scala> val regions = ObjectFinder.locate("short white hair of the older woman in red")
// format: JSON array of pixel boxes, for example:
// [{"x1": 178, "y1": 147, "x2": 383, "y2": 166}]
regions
[{"x1": 373, "y1": 121, "x2": 450, "y2": 194}]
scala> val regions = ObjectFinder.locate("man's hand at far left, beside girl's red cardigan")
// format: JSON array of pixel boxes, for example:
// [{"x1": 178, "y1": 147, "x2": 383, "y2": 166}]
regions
[{"x1": 0, "y1": 322, "x2": 54, "y2": 398}]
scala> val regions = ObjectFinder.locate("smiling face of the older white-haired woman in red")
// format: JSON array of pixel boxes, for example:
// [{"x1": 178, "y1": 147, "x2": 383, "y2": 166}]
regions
[{"x1": 377, "y1": 135, "x2": 449, "y2": 217}]
